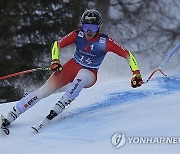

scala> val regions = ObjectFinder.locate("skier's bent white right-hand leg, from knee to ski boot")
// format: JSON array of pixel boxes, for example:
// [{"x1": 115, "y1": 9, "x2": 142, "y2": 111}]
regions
[{"x1": 47, "y1": 69, "x2": 96, "y2": 120}]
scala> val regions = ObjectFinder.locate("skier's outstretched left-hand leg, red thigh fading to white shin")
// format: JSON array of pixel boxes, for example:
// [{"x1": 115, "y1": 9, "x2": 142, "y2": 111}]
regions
[{"x1": 2, "y1": 59, "x2": 80, "y2": 124}]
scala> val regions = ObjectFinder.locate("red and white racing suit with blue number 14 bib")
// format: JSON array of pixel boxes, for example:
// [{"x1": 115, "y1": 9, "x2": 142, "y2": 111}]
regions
[{"x1": 16, "y1": 30, "x2": 139, "y2": 113}]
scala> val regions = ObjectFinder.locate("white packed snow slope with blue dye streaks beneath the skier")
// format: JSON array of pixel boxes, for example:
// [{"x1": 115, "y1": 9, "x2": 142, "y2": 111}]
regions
[{"x1": 0, "y1": 75, "x2": 180, "y2": 154}]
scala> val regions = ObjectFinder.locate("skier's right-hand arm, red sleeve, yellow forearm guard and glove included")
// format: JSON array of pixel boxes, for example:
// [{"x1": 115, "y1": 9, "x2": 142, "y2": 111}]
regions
[{"x1": 106, "y1": 37, "x2": 143, "y2": 88}]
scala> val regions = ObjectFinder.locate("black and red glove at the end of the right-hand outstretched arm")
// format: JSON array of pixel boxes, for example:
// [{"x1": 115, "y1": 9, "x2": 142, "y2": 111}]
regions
[{"x1": 131, "y1": 70, "x2": 143, "y2": 88}]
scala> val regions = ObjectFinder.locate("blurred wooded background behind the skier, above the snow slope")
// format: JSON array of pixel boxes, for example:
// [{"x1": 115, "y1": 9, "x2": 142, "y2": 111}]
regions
[{"x1": 0, "y1": 0, "x2": 180, "y2": 103}]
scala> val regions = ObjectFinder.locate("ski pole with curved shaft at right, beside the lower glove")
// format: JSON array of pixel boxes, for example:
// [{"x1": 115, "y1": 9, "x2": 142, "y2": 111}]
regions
[{"x1": 143, "y1": 43, "x2": 180, "y2": 83}]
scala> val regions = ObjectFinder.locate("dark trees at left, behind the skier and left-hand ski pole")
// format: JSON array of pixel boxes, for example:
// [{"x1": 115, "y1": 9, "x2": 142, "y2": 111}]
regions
[{"x1": 0, "y1": 0, "x2": 93, "y2": 102}]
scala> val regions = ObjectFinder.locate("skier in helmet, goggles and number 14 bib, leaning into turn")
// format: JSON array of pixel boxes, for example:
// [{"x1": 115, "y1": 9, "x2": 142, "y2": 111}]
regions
[{"x1": 1, "y1": 10, "x2": 143, "y2": 131}]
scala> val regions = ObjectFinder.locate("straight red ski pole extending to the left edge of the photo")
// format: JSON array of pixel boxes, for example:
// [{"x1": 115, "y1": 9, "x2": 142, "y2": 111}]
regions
[{"x1": 0, "y1": 67, "x2": 50, "y2": 80}]
